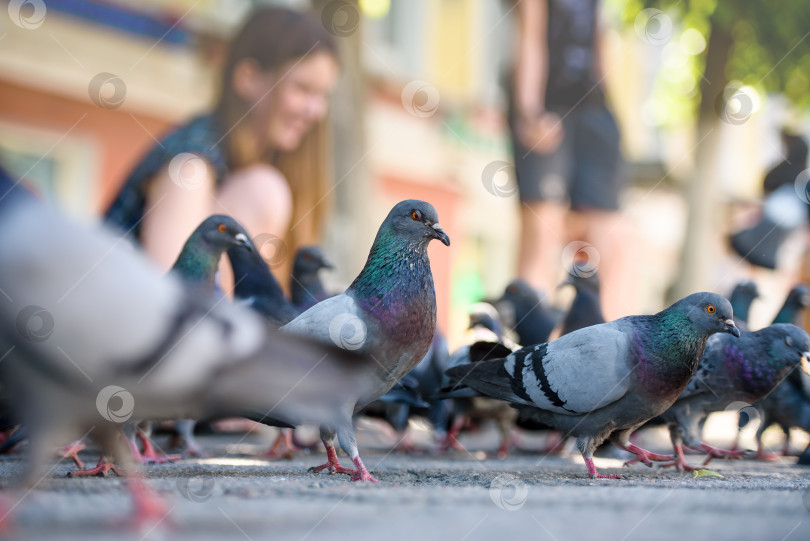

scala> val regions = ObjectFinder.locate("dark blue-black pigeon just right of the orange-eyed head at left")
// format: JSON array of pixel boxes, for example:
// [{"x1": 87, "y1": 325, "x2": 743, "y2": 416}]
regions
[{"x1": 227, "y1": 246, "x2": 300, "y2": 327}]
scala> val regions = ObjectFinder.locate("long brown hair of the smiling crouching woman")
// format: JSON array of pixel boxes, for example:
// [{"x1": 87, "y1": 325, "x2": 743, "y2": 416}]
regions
[{"x1": 215, "y1": 7, "x2": 338, "y2": 282}]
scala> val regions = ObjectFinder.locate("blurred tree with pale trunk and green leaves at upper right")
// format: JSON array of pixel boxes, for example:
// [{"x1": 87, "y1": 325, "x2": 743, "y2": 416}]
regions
[{"x1": 625, "y1": 0, "x2": 810, "y2": 297}]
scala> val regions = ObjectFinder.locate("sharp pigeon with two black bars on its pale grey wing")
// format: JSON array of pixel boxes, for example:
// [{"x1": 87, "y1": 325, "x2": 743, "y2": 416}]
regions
[{"x1": 447, "y1": 293, "x2": 740, "y2": 478}]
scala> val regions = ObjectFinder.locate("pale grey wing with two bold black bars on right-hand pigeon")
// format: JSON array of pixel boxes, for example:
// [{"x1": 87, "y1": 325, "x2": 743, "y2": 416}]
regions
[{"x1": 504, "y1": 322, "x2": 632, "y2": 415}]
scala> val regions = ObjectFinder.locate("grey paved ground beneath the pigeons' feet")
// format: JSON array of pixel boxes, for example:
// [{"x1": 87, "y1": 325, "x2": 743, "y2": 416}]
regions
[{"x1": 0, "y1": 426, "x2": 810, "y2": 541}]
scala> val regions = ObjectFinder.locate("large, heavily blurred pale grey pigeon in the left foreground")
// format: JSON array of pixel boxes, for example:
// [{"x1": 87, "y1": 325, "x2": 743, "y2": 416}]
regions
[{"x1": 0, "y1": 188, "x2": 372, "y2": 521}]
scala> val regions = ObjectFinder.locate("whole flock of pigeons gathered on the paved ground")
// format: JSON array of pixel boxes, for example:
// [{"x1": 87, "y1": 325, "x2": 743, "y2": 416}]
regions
[{"x1": 0, "y1": 163, "x2": 810, "y2": 519}]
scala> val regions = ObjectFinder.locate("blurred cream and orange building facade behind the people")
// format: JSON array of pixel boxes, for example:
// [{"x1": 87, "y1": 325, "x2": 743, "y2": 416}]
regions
[{"x1": 0, "y1": 0, "x2": 807, "y2": 342}]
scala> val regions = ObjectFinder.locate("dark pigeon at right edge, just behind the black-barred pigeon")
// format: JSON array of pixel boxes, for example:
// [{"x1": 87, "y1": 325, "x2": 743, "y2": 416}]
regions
[{"x1": 662, "y1": 323, "x2": 810, "y2": 471}]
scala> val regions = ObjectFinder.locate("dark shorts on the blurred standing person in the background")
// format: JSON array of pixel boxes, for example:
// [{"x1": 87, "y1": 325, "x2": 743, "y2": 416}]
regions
[{"x1": 510, "y1": 104, "x2": 623, "y2": 210}]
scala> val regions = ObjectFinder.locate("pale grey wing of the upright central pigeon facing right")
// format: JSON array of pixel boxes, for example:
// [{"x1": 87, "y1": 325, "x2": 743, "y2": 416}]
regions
[{"x1": 281, "y1": 293, "x2": 368, "y2": 350}]
